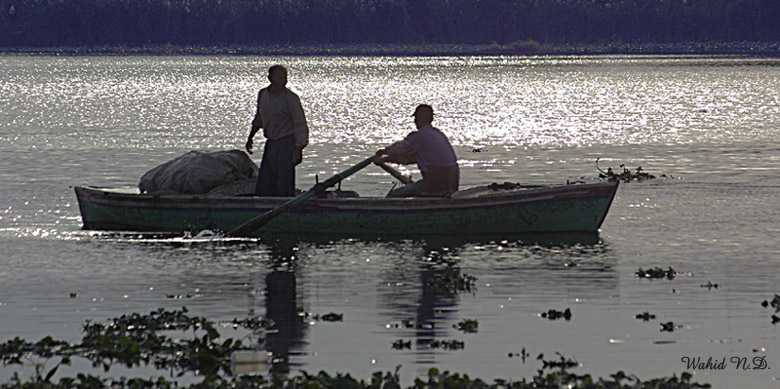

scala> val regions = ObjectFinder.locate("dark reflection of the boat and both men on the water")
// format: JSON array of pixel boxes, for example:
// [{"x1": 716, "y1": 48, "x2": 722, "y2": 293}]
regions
[{"x1": 120, "y1": 233, "x2": 618, "y2": 375}]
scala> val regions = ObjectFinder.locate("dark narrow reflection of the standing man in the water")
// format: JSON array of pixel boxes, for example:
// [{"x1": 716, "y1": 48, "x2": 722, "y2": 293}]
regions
[{"x1": 265, "y1": 242, "x2": 304, "y2": 374}]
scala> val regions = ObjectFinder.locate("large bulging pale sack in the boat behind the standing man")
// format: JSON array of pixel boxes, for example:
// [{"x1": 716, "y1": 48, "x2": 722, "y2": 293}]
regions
[{"x1": 138, "y1": 150, "x2": 258, "y2": 194}]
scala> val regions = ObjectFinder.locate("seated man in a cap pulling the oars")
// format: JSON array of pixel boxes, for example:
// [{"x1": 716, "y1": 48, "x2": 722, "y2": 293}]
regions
[{"x1": 376, "y1": 104, "x2": 460, "y2": 197}]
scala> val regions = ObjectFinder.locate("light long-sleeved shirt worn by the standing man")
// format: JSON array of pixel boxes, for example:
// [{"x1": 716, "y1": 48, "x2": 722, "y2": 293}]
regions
[{"x1": 252, "y1": 88, "x2": 309, "y2": 148}]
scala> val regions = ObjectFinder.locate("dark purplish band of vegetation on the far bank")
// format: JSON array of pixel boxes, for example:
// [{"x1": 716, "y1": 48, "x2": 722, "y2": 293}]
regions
[{"x1": 0, "y1": 0, "x2": 780, "y2": 55}]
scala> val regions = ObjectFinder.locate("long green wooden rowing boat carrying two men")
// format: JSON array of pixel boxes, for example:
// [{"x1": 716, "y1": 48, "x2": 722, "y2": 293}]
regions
[{"x1": 75, "y1": 182, "x2": 618, "y2": 236}]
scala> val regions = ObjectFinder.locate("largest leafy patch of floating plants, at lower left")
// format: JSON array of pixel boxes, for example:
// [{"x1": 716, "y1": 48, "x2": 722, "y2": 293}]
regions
[{"x1": 0, "y1": 308, "x2": 270, "y2": 381}]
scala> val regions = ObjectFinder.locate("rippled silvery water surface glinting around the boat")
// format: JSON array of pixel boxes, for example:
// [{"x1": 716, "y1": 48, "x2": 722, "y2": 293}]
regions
[{"x1": 0, "y1": 56, "x2": 780, "y2": 387}]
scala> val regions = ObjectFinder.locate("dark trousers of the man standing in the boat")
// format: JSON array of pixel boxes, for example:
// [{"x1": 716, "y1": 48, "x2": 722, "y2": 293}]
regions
[{"x1": 255, "y1": 135, "x2": 295, "y2": 197}]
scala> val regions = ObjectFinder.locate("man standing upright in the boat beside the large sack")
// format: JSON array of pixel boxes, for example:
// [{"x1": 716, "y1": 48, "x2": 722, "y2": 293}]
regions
[{"x1": 246, "y1": 65, "x2": 309, "y2": 197}]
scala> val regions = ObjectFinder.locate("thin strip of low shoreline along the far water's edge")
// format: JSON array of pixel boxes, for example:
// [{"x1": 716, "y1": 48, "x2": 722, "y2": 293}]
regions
[{"x1": 0, "y1": 41, "x2": 780, "y2": 58}]
